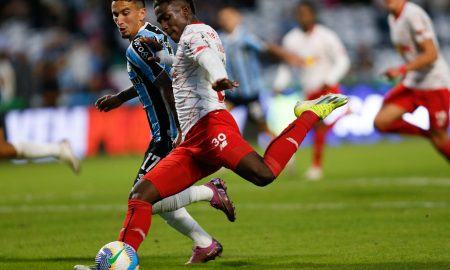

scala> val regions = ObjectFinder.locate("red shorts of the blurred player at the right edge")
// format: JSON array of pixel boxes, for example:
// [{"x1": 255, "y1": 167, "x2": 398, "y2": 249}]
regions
[{"x1": 384, "y1": 84, "x2": 450, "y2": 130}]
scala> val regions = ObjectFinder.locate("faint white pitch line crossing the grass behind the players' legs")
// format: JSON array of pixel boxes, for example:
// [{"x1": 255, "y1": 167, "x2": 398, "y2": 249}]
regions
[{"x1": 0, "y1": 201, "x2": 450, "y2": 214}]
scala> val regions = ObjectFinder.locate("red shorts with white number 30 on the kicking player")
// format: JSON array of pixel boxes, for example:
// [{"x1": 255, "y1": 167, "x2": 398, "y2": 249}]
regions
[{"x1": 143, "y1": 110, "x2": 255, "y2": 198}]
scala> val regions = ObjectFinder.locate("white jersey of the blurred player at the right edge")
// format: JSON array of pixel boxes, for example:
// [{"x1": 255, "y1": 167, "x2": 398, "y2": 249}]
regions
[{"x1": 388, "y1": 2, "x2": 450, "y2": 90}]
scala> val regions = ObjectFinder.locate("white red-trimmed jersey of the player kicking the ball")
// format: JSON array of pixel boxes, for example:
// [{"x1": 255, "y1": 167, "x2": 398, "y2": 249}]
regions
[{"x1": 172, "y1": 23, "x2": 226, "y2": 138}]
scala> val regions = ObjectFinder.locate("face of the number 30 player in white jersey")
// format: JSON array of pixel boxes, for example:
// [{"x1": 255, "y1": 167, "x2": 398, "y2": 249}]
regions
[{"x1": 155, "y1": 1, "x2": 190, "y2": 42}]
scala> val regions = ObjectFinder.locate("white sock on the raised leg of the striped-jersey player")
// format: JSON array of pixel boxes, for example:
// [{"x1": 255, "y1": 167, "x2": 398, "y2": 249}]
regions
[{"x1": 153, "y1": 185, "x2": 214, "y2": 214}]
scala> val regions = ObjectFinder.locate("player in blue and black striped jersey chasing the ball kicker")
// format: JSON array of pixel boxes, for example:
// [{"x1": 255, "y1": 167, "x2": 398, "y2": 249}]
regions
[{"x1": 75, "y1": 0, "x2": 235, "y2": 270}]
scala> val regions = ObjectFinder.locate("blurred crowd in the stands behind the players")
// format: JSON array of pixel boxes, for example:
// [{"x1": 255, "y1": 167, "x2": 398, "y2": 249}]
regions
[{"x1": 0, "y1": 0, "x2": 450, "y2": 112}]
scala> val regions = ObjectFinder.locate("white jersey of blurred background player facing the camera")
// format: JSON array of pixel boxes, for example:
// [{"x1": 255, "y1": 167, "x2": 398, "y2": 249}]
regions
[{"x1": 274, "y1": 24, "x2": 350, "y2": 94}]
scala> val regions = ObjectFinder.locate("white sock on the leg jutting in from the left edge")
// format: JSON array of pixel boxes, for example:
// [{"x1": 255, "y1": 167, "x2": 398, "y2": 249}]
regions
[{"x1": 12, "y1": 142, "x2": 61, "y2": 159}]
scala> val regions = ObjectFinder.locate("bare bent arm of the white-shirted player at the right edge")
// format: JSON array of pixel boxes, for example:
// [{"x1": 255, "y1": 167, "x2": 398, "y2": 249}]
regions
[{"x1": 385, "y1": 39, "x2": 438, "y2": 80}]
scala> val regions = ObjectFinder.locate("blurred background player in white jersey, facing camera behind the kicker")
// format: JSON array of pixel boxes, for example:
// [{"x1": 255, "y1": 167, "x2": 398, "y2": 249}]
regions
[{"x1": 274, "y1": 1, "x2": 350, "y2": 180}]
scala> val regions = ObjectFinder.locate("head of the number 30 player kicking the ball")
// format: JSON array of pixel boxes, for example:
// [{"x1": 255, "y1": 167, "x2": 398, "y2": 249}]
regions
[{"x1": 153, "y1": 0, "x2": 195, "y2": 42}]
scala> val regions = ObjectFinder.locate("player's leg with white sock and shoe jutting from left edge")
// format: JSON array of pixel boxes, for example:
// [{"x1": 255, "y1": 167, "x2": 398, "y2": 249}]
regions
[{"x1": 0, "y1": 115, "x2": 80, "y2": 173}]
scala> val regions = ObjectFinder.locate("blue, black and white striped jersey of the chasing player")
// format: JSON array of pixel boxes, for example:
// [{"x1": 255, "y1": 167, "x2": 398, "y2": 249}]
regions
[{"x1": 127, "y1": 23, "x2": 177, "y2": 141}]
